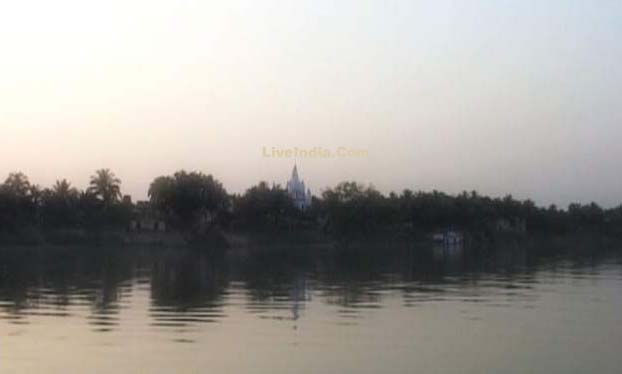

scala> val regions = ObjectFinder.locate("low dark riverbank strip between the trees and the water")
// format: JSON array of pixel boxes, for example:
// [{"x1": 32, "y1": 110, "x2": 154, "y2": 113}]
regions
[{"x1": 0, "y1": 228, "x2": 622, "y2": 253}]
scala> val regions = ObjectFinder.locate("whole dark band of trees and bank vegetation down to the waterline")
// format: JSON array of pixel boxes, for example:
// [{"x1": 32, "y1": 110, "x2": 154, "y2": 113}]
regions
[{"x1": 0, "y1": 169, "x2": 622, "y2": 250}]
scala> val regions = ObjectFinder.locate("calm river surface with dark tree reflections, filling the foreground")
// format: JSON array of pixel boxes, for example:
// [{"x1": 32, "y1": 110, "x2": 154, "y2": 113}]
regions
[{"x1": 0, "y1": 241, "x2": 622, "y2": 374}]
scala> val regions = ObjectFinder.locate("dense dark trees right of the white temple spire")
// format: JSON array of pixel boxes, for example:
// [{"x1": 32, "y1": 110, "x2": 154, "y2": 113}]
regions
[{"x1": 316, "y1": 182, "x2": 622, "y2": 238}]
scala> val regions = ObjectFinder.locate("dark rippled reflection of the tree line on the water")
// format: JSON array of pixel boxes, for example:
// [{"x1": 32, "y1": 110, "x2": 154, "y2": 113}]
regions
[{"x1": 0, "y1": 243, "x2": 620, "y2": 332}]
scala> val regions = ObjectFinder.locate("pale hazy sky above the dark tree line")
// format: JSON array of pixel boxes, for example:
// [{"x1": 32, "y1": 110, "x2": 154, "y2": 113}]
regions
[{"x1": 0, "y1": 0, "x2": 622, "y2": 206}]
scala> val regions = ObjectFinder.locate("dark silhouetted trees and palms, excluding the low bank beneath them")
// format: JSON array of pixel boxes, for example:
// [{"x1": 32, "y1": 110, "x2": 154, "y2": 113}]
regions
[{"x1": 0, "y1": 169, "x2": 622, "y2": 240}]
